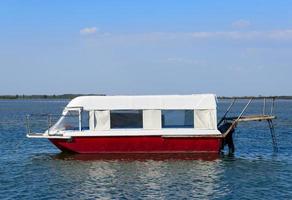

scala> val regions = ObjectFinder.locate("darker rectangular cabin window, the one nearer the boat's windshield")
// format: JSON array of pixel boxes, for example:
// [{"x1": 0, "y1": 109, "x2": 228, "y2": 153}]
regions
[{"x1": 110, "y1": 110, "x2": 143, "y2": 128}]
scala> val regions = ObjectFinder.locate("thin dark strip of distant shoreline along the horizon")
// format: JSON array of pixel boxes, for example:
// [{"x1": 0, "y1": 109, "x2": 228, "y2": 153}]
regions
[{"x1": 0, "y1": 94, "x2": 292, "y2": 100}]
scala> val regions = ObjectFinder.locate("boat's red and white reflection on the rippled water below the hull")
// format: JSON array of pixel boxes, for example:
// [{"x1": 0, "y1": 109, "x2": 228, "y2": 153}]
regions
[{"x1": 52, "y1": 153, "x2": 228, "y2": 199}]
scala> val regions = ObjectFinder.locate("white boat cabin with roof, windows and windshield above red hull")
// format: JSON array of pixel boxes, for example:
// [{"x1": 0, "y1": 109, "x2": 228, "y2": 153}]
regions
[{"x1": 48, "y1": 94, "x2": 221, "y2": 137}]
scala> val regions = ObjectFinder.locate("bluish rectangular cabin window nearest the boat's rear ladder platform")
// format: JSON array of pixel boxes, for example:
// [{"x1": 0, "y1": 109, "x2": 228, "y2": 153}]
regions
[{"x1": 161, "y1": 110, "x2": 194, "y2": 128}]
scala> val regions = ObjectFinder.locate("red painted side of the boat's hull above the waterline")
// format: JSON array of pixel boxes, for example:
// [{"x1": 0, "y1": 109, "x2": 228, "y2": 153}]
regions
[{"x1": 50, "y1": 136, "x2": 221, "y2": 153}]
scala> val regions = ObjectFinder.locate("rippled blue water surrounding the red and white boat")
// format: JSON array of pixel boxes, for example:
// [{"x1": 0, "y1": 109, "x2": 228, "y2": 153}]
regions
[{"x1": 0, "y1": 100, "x2": 292, "y2": 199}]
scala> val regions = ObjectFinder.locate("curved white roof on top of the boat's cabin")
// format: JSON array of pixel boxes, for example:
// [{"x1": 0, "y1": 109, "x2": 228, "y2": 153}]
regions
[{"x1": 67, "y1": 94, "x2": 216, "y2": 110}]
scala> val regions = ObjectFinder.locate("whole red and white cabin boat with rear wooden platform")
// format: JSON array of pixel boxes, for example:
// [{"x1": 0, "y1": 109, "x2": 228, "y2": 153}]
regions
[{"x1": 27, "y1": 94, "x2": 274, "y2": 154}]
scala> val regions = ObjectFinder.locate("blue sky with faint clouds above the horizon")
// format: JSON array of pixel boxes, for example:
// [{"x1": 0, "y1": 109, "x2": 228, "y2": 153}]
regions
[{"x1": 0, "y1": 0, "x2": 292, "y2": 96}]
